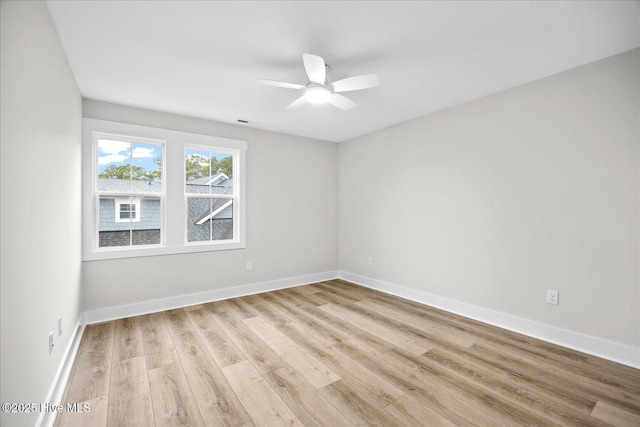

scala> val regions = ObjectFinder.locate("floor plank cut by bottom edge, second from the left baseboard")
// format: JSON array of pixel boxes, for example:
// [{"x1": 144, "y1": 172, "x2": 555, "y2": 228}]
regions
[{"x1": 107, "y1": 356, "x2": 155, "y2": 427}]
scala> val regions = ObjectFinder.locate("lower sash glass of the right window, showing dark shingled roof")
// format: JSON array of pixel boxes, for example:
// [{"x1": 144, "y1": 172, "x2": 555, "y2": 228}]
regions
[{"x1": 187, "y1": 197, "x2": 233, "y2": 242}]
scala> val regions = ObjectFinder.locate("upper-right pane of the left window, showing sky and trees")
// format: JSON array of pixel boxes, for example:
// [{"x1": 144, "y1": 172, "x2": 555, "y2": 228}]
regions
[{"x1": 131, "y1": 142, "x2": 162, "y2": 193}]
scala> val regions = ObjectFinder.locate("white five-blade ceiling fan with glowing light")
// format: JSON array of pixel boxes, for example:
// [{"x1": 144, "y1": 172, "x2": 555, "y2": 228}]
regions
[{"x1": 258, "y1": 53, "x2": 380, "y2": 111}]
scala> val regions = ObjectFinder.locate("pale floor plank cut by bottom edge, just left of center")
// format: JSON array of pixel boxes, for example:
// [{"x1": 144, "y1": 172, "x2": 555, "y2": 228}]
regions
[{"x1": 222, "y1": 361, "x2": 304, "y2": 427}]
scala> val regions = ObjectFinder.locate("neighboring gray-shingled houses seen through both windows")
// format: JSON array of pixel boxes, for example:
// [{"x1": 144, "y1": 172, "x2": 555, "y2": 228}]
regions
[{"x1": 98, "y1": 173, "x2": 233, "y2": 247}]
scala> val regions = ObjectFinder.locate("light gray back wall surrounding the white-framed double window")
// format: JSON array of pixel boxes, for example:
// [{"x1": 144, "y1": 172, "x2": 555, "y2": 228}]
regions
[{"x1": 83, "y1": 100, "x2": 338, "y2": 310}]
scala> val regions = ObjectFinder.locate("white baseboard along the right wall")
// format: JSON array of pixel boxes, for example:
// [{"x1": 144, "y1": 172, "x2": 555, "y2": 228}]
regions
[{"x1": 338, "y1": 271, "x2": 640, "y2": 368}]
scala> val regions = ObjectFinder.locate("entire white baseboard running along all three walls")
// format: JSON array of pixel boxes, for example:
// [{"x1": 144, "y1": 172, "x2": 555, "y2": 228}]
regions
[{"x1": 41, "y1": 271, "x2": 640, "y2": 427}]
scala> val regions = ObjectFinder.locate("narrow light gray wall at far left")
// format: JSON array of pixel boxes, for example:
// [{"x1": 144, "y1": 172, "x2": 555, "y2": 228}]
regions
[{"x1": 0, "y1": 1, "x2": 82, "y2": 426}]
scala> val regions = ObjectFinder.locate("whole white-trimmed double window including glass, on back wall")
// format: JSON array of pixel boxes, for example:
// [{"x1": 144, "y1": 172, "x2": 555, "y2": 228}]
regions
[{"x1": 83, "y1": 119, "x2": 247, "y2": 260}]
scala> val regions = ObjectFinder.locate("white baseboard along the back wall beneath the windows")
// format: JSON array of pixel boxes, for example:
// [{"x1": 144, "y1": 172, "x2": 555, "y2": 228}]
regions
[{"x1": 82, "y1": 271, "x2": 338, "y2": 324}]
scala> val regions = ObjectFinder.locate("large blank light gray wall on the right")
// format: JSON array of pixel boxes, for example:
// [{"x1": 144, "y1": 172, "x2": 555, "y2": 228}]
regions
[{"x1": 339, "y1": 50, "x2": 640, "y2": 347}]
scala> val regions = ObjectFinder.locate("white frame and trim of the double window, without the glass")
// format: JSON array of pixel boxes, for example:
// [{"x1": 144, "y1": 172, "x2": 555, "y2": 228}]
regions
[{"x1": 82, "y1": 118, "x2": 247, "y2": 261}]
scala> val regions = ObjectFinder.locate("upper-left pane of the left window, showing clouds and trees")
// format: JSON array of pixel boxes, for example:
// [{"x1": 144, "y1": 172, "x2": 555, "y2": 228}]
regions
[{"x1": 98, "y1": 139, "x2": 131, "y2": 193}]
